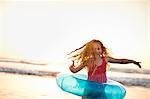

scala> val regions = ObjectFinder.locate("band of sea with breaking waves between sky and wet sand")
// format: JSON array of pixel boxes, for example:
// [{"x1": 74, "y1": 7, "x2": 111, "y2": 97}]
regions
[{"x1": 0, "y1": 62, "x2": 150, "y2": 88}]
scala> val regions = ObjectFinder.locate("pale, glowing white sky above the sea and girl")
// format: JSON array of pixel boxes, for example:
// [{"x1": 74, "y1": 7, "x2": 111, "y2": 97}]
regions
[{"x1": 0, "y1": 0, "x2": 150, "y2": 68}]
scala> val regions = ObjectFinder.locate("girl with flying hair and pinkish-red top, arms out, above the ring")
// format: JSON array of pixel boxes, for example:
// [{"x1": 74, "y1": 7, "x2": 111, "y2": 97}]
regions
[{"x1": 69, "y1": 39, "x2": 141, "y2": 99}]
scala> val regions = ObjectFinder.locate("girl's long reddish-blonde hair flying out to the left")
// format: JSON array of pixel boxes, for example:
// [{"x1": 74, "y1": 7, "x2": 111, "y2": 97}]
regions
[{"x1": 68, "y1": 39, "x2": 108, "y2": 69}]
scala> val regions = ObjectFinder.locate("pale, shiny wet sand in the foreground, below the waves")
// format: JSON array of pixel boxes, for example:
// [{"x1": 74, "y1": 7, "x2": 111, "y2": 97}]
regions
[{"x1": 0, "y1": 73, "x2": 150, "y2": 99}]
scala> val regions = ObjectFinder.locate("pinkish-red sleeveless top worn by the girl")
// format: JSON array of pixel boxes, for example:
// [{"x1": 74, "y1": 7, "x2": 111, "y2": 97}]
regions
[{"x1": 88, "y1": 57, "x2": 107, "y2": 83}]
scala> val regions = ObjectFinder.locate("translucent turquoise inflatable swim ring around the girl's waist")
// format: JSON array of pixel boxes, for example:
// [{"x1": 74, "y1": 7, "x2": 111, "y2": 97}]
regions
[{"x1": 56, "y1": 74, "x2": 126, "y2": 99}]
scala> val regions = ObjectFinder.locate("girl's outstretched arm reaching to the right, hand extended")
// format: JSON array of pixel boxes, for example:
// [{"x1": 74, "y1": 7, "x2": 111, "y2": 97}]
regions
[{"x1": 107, "y1": 57, "x2": 141, "y2": 68}]
